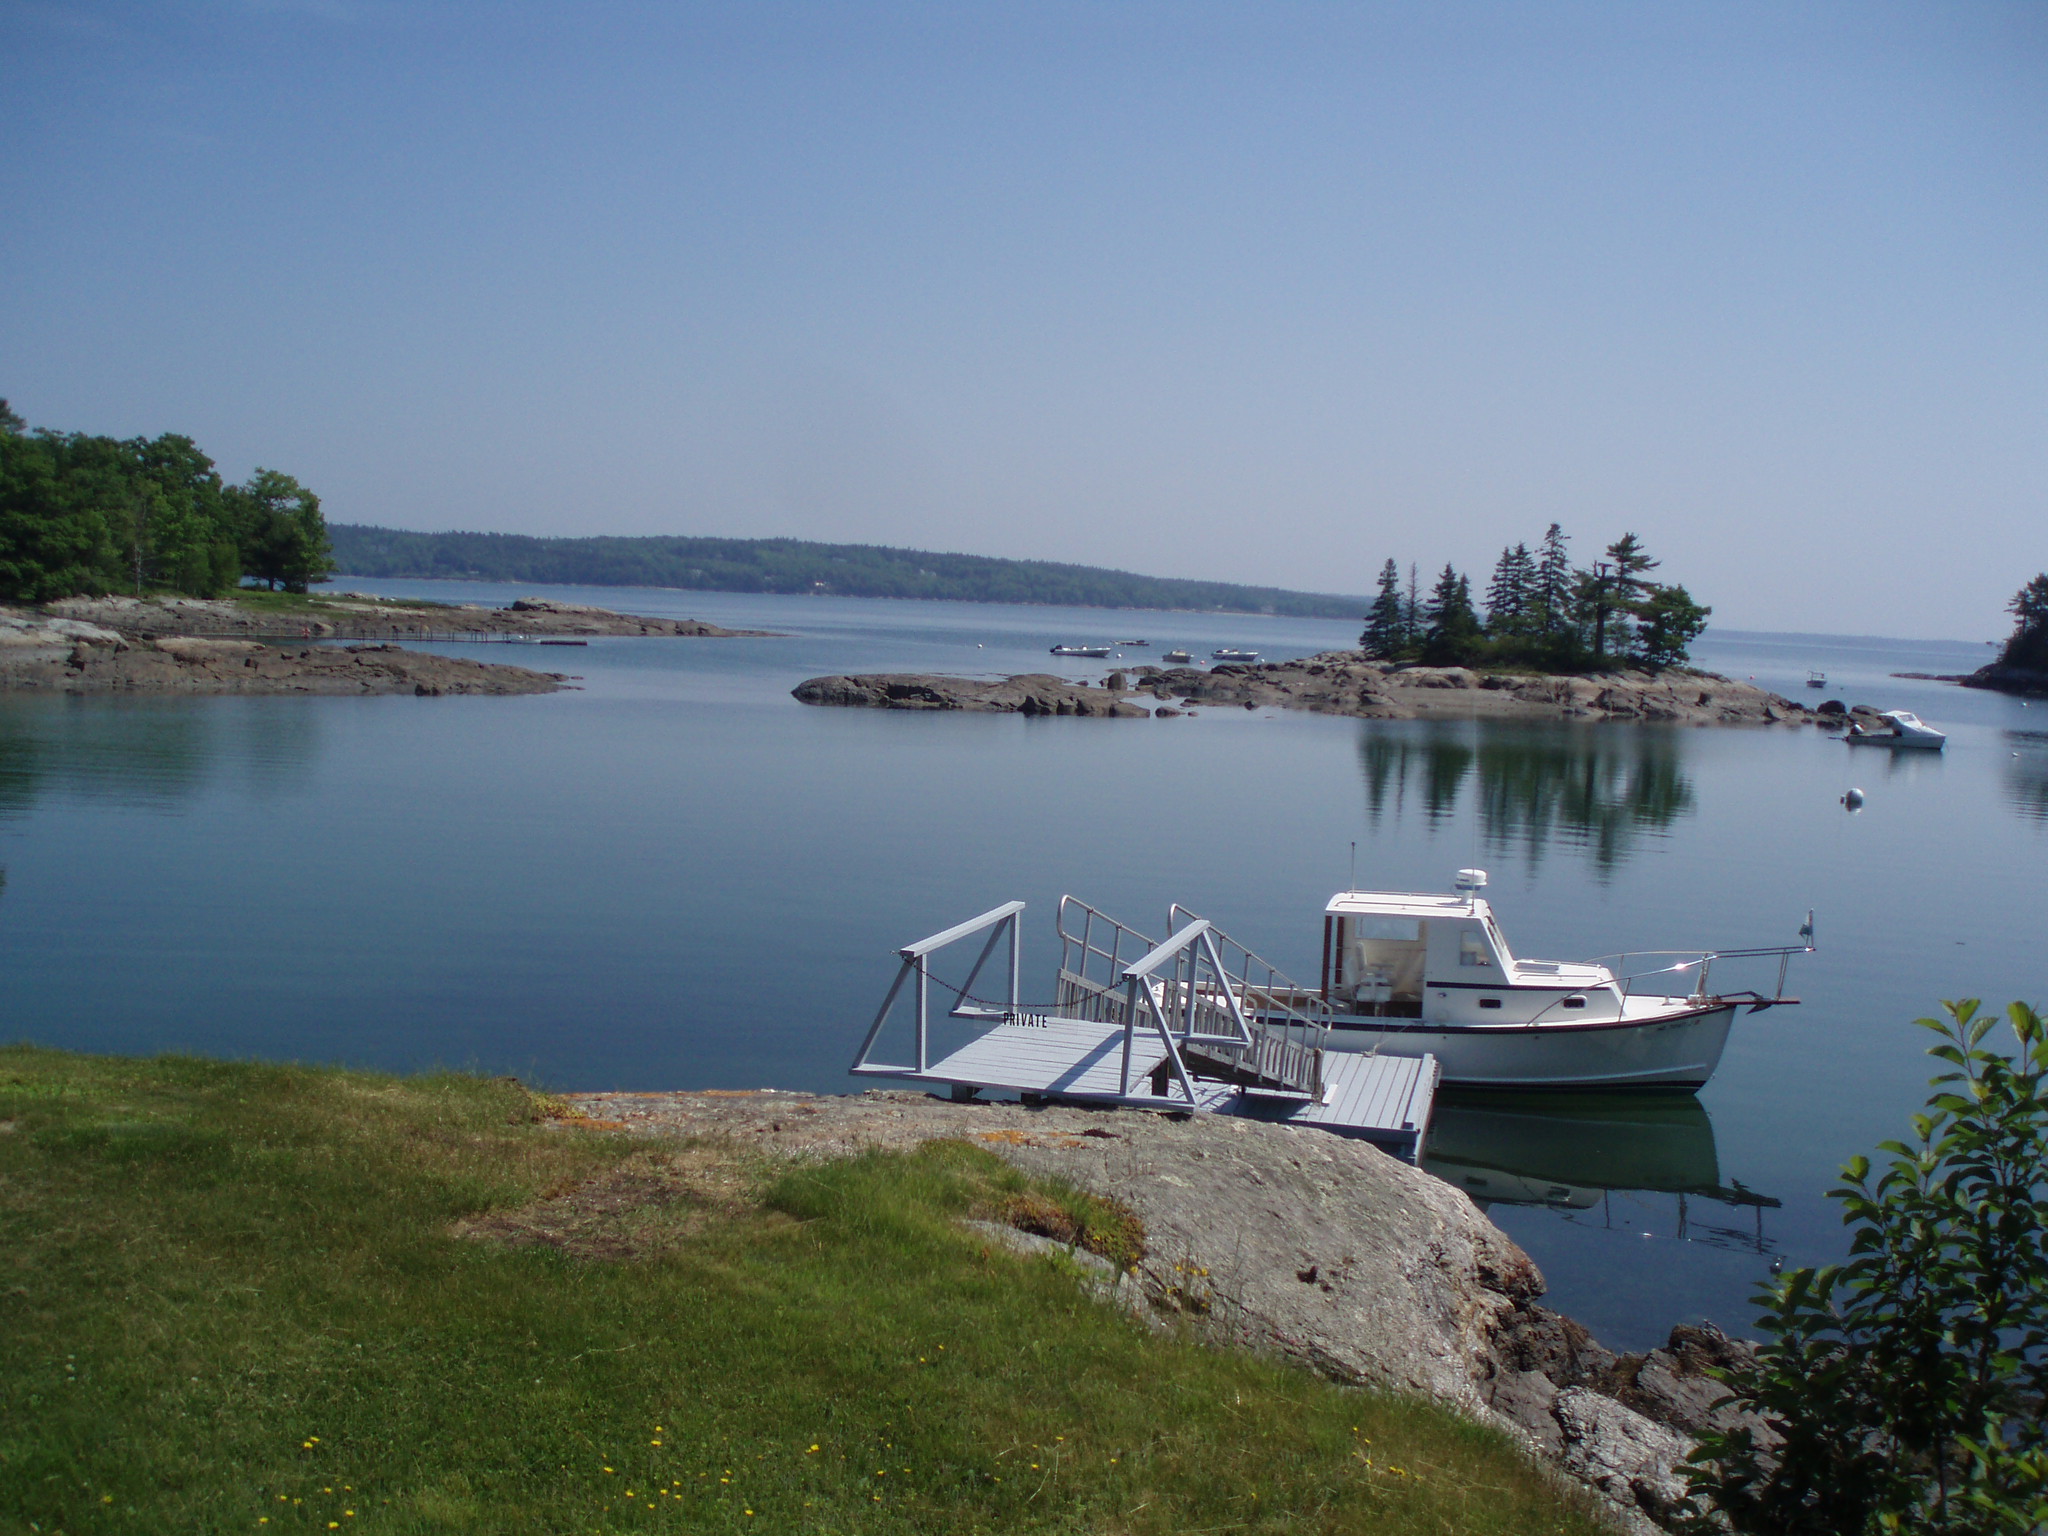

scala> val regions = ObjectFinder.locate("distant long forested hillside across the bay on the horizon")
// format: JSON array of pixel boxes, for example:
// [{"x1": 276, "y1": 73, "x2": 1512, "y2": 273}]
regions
[{"x1": 328, "y1": 522, "x2": 1366, "y2": 618}]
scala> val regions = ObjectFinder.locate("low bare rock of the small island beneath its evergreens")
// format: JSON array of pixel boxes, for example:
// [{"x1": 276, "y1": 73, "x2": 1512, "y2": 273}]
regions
[{"x1": 795, "y1": 651, "x2": 1815, "y2": 725}]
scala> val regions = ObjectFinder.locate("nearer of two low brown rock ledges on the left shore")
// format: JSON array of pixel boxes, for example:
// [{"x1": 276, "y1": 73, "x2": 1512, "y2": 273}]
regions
[{"x1": 0, "y1": 614, "x2": 565, "y2": 696}]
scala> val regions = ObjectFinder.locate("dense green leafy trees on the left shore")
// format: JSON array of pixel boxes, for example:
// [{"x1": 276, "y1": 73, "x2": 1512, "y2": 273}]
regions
[{"x1": 0, "y1": 399, "x2": 334, "y2": 602}]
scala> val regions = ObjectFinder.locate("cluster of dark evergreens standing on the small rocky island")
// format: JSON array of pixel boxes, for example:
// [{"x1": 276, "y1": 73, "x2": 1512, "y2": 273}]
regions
[{"x1": 1358, "y1": 522, "x2": 1712, "y2": 672}]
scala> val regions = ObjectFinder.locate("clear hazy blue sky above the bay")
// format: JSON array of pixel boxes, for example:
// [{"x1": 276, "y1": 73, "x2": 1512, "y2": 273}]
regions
[{"x1": 0, "y1": 0, "x2": 2048, "y2": 639}]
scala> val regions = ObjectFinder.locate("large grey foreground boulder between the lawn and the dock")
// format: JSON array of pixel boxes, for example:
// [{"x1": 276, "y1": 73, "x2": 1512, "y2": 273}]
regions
[{"x1": 567, "y1": 1090, "x2": 1753, "y2": 1530}]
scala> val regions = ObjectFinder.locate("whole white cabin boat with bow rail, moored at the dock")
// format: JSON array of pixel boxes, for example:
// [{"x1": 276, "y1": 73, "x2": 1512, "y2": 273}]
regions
[{"x1": 1277, "y1": 870, "x2": 1812, "y2": 1092}]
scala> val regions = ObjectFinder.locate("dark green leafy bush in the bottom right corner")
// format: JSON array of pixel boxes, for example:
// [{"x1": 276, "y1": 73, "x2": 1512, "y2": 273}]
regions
[{"x1": 1690, "y1": 997, "x2": 2048, "y2": 1536}]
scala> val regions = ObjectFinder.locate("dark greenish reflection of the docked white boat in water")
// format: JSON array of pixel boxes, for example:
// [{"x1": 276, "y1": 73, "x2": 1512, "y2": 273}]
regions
[{"x1": 1421, "y1": 1094, "x2": 1780, "y2": 1253}]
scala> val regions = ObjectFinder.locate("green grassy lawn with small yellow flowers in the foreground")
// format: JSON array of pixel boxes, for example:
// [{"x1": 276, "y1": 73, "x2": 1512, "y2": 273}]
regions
[{"x1": 0, "y1": 1047, "x2": 1597, "y2": 1536}]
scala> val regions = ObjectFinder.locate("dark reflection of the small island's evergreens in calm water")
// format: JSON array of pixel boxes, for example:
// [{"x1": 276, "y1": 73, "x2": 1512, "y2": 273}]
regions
[{"x1": 1358, "y1": 721, "x2": 1694, "y2": 872}]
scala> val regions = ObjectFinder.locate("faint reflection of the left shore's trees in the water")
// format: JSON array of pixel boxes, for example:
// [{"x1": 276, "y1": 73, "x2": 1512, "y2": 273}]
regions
[{"x1": 0, "y1": 698, "x2": 319, "y2": 819}]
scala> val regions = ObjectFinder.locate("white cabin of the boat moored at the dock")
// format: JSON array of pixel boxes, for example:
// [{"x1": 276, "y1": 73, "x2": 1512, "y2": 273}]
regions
[{"x1": 1323, "y1": 877, "x2": 1618, "y2": 1022}]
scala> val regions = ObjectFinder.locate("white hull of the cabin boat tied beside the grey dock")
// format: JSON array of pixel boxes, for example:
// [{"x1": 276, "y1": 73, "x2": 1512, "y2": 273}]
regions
[{"x1": 1325, "y1": 1004, "x2": 1735, "y2": 1092}]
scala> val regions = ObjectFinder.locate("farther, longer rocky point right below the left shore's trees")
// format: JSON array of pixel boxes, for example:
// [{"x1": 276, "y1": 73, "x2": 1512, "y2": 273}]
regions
[{"x1": 43, "y1": 592, "x2": 766, "y2": 639}]
